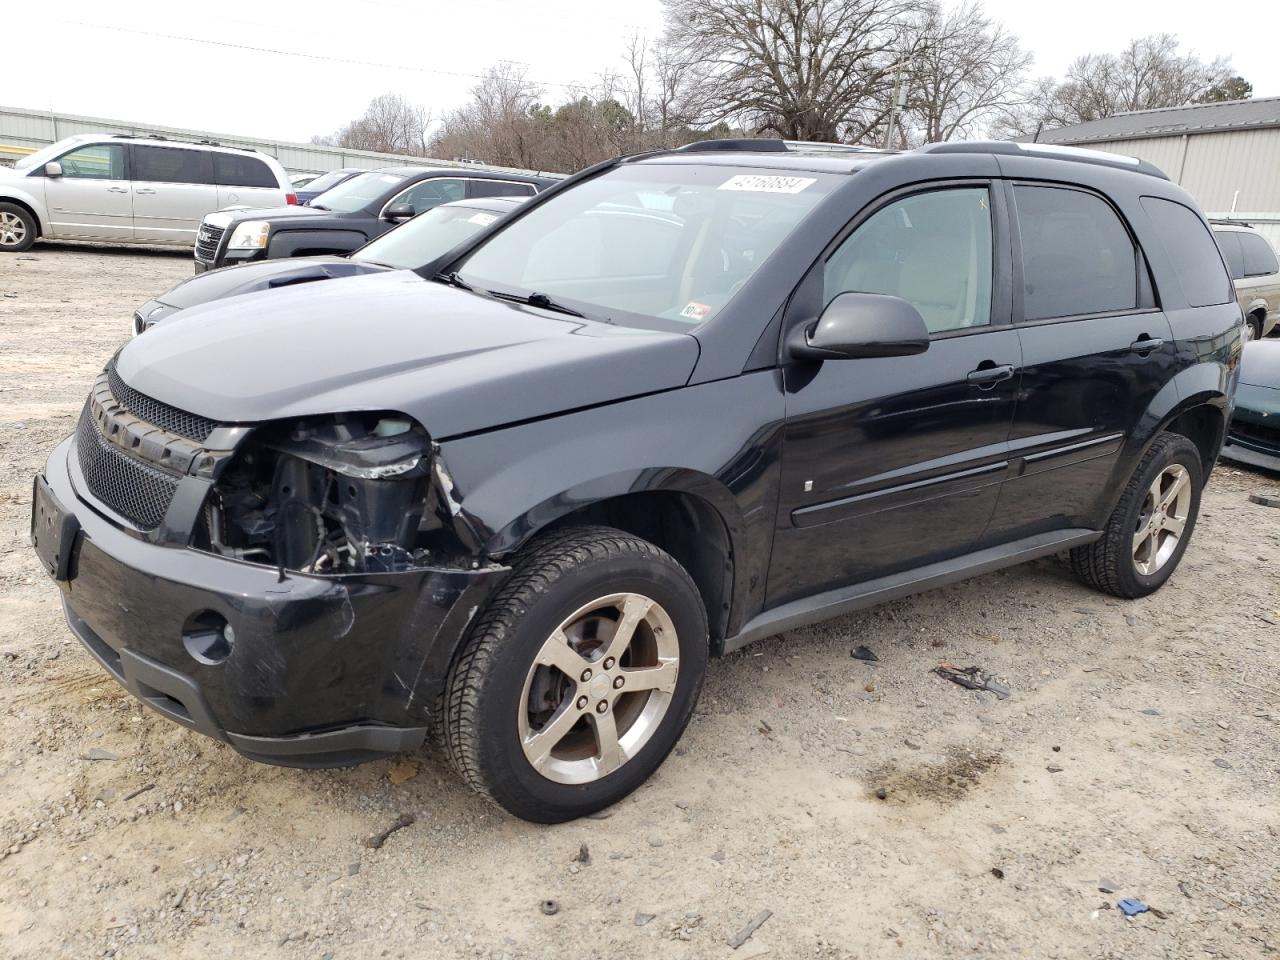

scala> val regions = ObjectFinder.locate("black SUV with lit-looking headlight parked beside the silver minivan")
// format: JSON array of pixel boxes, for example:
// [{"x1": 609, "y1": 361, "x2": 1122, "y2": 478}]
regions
[{"x1": 196, "y1": 166, "x2": 554, "y2": 274}]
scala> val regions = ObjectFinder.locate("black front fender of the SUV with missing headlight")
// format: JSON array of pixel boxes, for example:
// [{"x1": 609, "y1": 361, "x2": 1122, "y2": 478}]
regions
[{"x1": 440, "y1": 370, "x2": 783, "y2": 634}]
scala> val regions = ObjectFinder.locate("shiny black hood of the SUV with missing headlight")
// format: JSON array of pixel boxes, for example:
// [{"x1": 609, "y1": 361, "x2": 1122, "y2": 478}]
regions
[{"x1": 116, "y1": 268, "x2": 699, "y2": 440}]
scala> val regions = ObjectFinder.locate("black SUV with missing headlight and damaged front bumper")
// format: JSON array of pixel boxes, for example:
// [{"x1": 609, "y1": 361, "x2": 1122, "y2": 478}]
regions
[{"x1": 32, "y1": 141, "x2": 1243, "y2": 822}]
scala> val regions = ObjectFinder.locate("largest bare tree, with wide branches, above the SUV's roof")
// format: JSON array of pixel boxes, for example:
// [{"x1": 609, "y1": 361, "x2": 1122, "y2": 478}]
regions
[{"x1": 664, "y1": 0, "x2": 925, "y2": 141}]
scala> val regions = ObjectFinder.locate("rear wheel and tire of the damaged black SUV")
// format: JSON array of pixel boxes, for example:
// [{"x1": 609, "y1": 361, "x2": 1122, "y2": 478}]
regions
[{"x1": 1071, "y1": 434, "x2": 1204, "y2": 599}]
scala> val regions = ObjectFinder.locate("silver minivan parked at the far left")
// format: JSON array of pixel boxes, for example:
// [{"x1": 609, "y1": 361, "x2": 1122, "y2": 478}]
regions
[{"x1": 0, "y1": 134, "x2": 297, "y2": 253}]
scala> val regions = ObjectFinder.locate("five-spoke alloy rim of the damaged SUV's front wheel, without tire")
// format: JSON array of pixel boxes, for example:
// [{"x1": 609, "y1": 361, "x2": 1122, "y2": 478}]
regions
[{"x1": 518, "y1": 593, "x2": 680, "y2": 783}]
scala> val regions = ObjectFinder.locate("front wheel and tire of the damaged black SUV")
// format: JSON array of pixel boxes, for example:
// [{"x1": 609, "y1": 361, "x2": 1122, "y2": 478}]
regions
[{"x1": 438, "y1": 527, "x2": 708, "y2": 823}]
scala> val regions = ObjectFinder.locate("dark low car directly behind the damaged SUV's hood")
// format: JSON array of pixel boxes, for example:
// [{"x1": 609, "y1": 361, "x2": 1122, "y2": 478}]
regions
[{"x1": 133, "y1": 197, "x2": 525, "y2": 335}]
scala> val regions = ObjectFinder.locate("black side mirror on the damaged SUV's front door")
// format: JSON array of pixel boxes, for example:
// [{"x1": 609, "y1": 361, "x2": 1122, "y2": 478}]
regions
[{"x1": 787, "y1": 293, "x2": 929, "y2": 360}]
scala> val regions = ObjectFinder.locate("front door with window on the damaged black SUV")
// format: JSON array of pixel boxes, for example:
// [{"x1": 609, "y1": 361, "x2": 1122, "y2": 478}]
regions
[{"x1": 767, "y1": 182, "x2": 1021, "y2": 607}]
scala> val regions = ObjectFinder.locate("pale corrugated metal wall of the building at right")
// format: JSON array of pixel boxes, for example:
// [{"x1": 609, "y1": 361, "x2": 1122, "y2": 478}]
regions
[{"x1": 1082, "y1": 129, "x2": 1280, "y2": 250}]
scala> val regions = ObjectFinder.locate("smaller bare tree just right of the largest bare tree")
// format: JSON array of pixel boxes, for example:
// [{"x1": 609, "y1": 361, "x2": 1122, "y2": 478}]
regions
[{"x1": 902, "y1": 3, "x2": 1032, "y2": 143}]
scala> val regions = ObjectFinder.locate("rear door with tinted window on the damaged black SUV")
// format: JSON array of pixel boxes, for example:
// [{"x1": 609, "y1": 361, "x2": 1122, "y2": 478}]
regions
[{"x1": 988, "y1": 182, "x2": 1178, "y2": 540}]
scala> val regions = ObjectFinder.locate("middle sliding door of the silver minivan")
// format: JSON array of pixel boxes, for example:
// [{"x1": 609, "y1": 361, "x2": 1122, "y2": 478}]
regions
[{"x1": 129, "y1": 143, "x2": 218, "y2": 246}]
